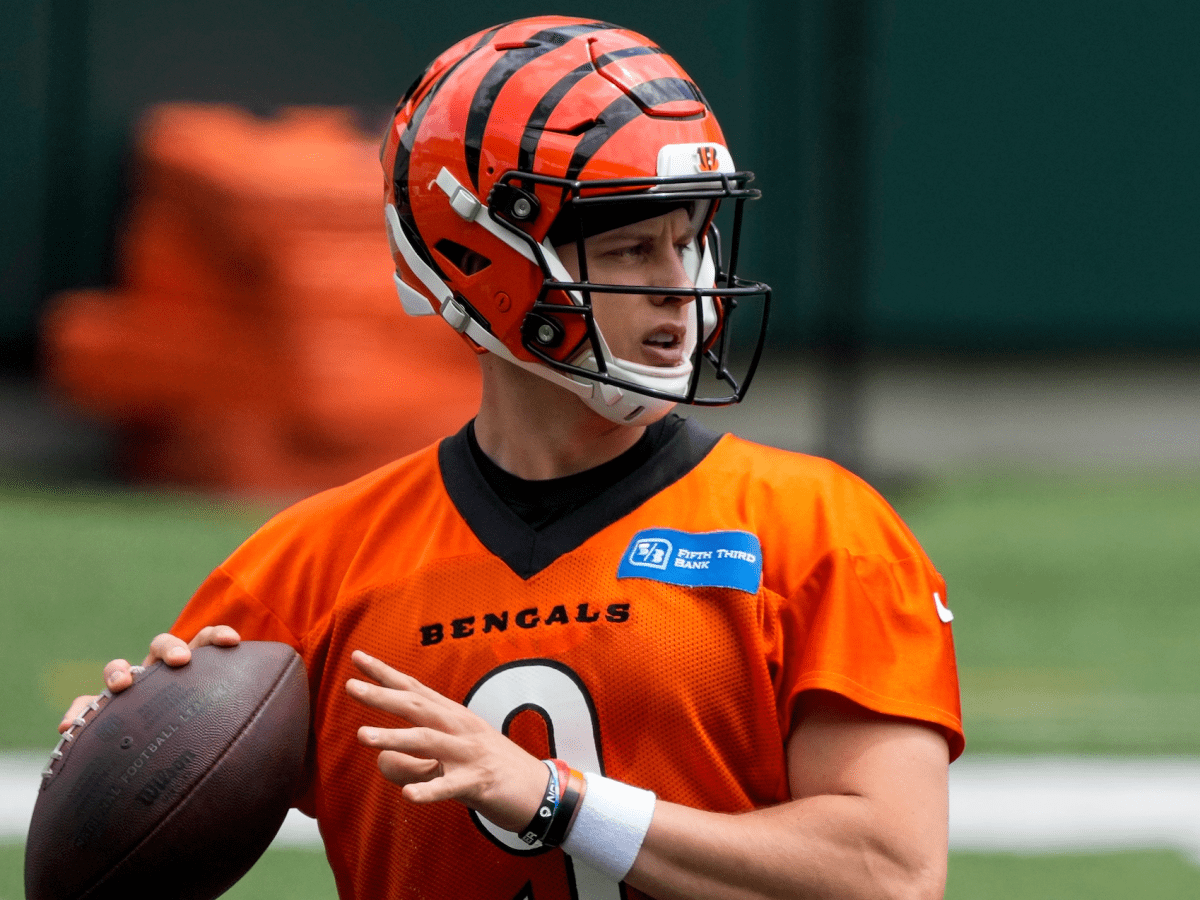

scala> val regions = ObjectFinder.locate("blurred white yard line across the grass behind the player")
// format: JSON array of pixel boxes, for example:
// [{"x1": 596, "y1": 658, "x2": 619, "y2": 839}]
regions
[{"x1": 7, "y1": 752, "x2": 1200, "y2": 863}]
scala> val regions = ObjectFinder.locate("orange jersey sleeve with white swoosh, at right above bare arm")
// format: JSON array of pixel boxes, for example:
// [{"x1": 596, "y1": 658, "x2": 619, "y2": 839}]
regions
[{"x1": 767, "y1": 460, "x2": 965, "y2": 760}]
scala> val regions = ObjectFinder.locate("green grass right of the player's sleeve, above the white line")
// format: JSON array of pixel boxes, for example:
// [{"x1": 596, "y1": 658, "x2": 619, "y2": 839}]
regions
[{"x1": 893, "y1": 473, "x2": 1200, "y2": 755}]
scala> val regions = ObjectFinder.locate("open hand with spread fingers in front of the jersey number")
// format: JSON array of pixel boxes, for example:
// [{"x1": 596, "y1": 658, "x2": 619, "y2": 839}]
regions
[{"x1": 346, "y1": 650, "x2": 550, "y2": 832}]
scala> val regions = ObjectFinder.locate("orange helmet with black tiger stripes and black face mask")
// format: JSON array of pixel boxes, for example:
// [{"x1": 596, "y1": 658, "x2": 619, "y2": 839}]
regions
[{"x1": 380, "y1": 16, "x2": 770, "y2": 424}]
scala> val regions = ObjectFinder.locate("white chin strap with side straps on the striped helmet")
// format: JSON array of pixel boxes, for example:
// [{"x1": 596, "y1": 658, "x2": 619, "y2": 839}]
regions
[{"x1": 384, "y1": 168, "x2": 716, "y2": 425}]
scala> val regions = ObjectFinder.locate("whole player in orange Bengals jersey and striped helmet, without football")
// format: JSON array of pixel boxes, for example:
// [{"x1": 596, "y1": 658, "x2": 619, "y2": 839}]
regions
[{"x1": 66, "y1": 17, "x2": 964, "y2": 900}]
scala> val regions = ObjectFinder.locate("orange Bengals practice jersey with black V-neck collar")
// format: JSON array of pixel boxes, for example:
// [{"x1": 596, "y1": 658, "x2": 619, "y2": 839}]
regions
[{"x1": 173, "y1": 422, "x2": 962, "y2": 900}]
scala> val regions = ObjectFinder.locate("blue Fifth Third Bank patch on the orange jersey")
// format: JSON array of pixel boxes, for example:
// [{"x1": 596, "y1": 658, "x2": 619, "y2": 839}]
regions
[{"x1": 617, "y1": 528, "x2": 762, "y2": 594}]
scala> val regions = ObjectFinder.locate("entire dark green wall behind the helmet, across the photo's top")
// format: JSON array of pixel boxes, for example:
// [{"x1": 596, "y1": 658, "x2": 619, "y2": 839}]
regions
[{"x1": 0, "y1": 0, "x2": 1200, "y2": 368}]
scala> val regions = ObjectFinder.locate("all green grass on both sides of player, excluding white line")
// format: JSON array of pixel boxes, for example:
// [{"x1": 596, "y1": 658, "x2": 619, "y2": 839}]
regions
[{"x1": 0, "y1": 473, "x2": 1200, "y2": 900}]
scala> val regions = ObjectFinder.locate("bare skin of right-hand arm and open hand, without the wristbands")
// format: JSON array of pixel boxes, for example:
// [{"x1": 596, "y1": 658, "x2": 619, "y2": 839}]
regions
[{"x1": 347, "y1": 654, "x2": 949, "y2": 900}]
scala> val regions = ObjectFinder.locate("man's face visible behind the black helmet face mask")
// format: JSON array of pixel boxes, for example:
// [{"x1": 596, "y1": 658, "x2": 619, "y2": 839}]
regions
[{"x1": 557, "y1": 209, "x2": 696, "y2": 367}]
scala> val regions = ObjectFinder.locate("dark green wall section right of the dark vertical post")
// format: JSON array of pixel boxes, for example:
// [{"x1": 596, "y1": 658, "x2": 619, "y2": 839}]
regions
[{"x1": 868, "y1": 0, "x2": 1200, "y2": 349}]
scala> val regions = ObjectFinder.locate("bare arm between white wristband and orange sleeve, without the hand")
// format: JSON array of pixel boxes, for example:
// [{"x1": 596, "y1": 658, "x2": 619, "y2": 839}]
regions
[{"x1": 625, "y1": 692, "x2": 949, "y2": 900}]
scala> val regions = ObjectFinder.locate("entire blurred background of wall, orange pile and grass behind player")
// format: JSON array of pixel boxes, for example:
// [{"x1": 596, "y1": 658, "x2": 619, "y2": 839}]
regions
[{"x1": 0, "y1": 0, "x2": 1200, "y2": 900}]
